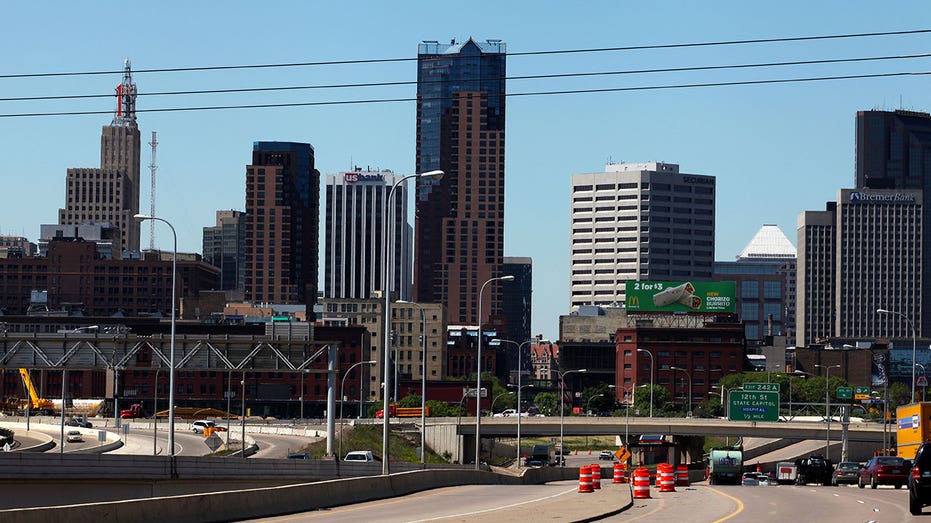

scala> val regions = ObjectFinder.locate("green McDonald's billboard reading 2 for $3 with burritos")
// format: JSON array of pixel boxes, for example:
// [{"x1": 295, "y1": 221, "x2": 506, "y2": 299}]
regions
[{"x1": 625, "y1": 281, "x2": 737, "y2": 313}]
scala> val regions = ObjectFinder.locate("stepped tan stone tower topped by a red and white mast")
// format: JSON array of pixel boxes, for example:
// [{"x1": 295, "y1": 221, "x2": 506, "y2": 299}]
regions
[{"x1": 58, "y1": 60, "x2": 140, "y2": 251}]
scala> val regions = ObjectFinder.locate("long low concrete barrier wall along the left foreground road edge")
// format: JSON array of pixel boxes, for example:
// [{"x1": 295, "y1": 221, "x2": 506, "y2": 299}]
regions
[{"x1": 0, "y1": 467, "x2": 578, "y2": 523}]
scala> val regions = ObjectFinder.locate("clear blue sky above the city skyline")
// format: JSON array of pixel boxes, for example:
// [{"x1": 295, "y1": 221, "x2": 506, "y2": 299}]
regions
[{"x1": 0, "y1": 1, "x2": 931, "y2": 339}]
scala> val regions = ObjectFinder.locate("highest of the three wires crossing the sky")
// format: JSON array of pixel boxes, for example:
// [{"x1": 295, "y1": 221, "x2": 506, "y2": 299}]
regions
[{"x1": 0, "y1": 29, "x2": 931, "y2": 79}]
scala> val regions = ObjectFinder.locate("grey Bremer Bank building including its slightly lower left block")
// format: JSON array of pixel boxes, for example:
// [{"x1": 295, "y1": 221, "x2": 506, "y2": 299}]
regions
[{"x1": 796, "y1": 189, "x2": 927, "y2": 347}]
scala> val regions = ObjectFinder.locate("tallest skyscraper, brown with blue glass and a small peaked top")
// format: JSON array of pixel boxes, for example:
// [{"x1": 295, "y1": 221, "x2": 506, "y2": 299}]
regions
[{"x1": 414, "y1": 39, "x2": 506, "y2": 325}]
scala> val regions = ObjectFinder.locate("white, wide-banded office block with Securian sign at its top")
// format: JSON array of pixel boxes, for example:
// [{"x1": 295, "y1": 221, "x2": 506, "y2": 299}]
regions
[{"x1": 569, "y1": 163, "x2": 715, "y2": 310}]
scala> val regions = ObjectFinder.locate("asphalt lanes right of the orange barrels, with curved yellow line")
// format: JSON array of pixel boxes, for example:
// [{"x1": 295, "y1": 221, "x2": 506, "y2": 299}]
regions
[{"x1": 603, "y1": 483, "x2": 916, "y2": 523}]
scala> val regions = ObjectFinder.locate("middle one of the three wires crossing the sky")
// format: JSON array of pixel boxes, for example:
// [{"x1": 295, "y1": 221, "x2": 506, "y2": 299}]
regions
[{"x1": 0, "y1": 53, "x2": 931, "y2": 102}]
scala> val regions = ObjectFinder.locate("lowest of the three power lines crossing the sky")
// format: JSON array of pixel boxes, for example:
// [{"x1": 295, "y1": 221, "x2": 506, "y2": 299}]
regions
[{"x1": 0, "y1": 71, "x2": 931, "y2": 118}]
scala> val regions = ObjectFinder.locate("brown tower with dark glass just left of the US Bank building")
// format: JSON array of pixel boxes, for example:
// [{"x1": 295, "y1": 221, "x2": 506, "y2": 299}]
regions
[{"x1": 244, "y1": 142, "x2": 320, "y2": 321}]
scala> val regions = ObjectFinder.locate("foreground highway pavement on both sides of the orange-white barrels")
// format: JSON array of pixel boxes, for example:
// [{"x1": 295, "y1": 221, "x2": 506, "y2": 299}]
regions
[{"x1": 242, "y1": 482, "x2": 916, "y2": 523}]
